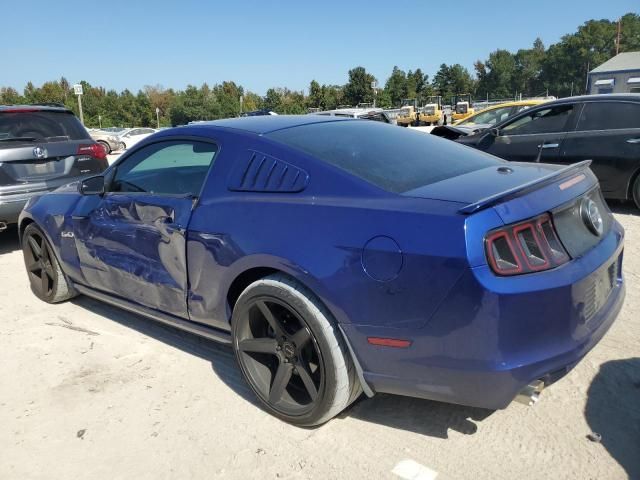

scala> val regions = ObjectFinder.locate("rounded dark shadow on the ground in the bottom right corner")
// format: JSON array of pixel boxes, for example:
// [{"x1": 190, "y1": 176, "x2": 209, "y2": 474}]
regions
[{"x1": 584, "y1": 357, "x2": 640, "y2": 478}]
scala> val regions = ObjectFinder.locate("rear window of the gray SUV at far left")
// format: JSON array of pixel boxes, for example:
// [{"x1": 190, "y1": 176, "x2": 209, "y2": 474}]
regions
[{"x1": 0, "y1": 111, "x2": 89, "y2": 146}]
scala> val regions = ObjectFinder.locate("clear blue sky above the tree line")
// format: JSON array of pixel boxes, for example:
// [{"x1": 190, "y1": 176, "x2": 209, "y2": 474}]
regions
[{"x1": 0, "y1": 0, "x2": 640, "y2": 95}]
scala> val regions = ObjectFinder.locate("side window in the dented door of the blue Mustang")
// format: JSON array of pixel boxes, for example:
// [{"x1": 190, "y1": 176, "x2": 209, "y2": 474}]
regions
[{"x1": 111, "y1": 140, "x2": 218, "y2": 197}]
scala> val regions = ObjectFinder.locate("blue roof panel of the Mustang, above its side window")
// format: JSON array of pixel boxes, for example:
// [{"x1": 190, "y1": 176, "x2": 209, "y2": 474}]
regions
[{"x1": 180, "y1": 115, "x2": 353, "y2": 135}]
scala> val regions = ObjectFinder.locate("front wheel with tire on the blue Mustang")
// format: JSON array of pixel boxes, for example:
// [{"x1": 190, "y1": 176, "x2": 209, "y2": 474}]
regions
[{"x1": 22, "y1": 223, "x2": 75, "y2": 303}]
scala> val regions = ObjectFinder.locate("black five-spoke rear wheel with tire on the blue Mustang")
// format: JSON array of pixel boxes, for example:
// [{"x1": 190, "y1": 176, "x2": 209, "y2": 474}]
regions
[{"x1": 232, "y1": 274, "x2": 362, "y2": 426}]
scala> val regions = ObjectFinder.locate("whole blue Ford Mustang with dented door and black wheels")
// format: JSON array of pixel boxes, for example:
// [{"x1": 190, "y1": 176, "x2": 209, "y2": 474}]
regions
[{"x1": 20, "y1": 116, "x2": 624, "y2": 425}]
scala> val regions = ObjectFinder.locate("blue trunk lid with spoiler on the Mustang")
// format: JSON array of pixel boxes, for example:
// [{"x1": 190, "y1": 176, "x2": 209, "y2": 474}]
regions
[{"x1": 405, "y1": 161, "x2": 613, "y2": 258}]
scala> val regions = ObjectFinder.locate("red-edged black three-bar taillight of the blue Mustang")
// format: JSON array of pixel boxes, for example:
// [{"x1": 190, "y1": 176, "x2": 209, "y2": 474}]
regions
[{"x1": 485, "y1": 214, "x2": 569, "y2": 275}]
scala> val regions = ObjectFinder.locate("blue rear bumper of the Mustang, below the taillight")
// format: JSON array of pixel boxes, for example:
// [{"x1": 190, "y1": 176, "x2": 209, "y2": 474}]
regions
[{"x1": 342, "y1": 221, "x2": 625, "y2": 409}]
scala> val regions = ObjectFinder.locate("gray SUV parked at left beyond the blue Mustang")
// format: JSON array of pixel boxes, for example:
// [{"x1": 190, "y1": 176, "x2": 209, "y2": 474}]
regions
[{"x1": 0, "y1": 105, "x2": 108, "y2": 232}]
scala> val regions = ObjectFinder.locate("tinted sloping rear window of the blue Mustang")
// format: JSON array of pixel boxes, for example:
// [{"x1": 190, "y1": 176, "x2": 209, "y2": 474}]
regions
[{"x1": 266, "y1": 120, "x2": 502, "y2": 193}]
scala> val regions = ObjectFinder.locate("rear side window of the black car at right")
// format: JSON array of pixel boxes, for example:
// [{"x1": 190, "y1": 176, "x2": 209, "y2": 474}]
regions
[{"x1": 576, "y1": 102, "x2": 640, "y2": 131}]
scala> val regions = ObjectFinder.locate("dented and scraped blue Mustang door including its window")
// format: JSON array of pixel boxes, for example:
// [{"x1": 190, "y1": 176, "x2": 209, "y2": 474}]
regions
[{"x1": 73, "y1": 139, "x2": 218, "y2": 318}]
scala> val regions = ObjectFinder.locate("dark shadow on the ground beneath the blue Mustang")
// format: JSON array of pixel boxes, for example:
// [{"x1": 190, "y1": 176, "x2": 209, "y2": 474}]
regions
[{"x1": 72, "y1": 296, "x2": 493, "y2": 439}]
